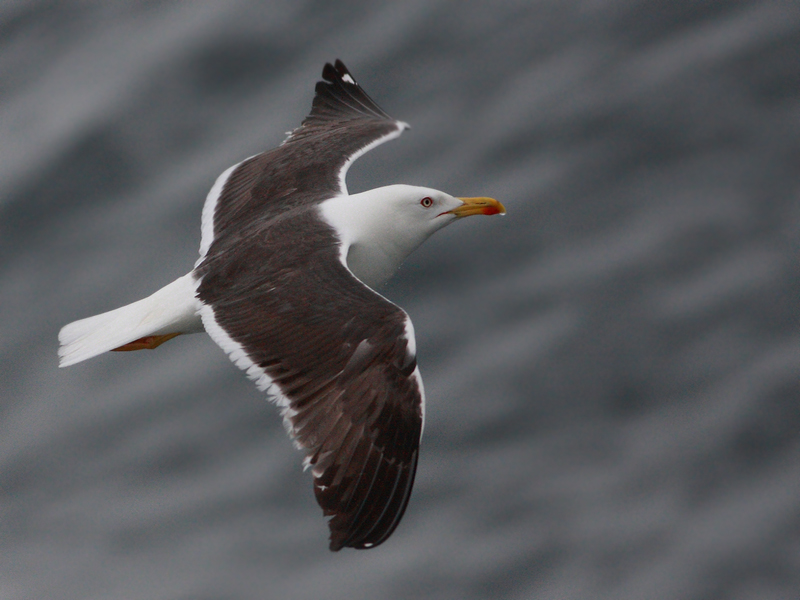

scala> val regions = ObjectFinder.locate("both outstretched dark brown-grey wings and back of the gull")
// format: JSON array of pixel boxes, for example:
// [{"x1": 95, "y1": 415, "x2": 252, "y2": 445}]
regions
[{"x1": 194, "y1": 61, "x2": 424, "y2": 550}]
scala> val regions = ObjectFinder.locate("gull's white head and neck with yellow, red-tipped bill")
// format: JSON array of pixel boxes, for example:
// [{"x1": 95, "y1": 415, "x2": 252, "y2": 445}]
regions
[{"x1": 320, "y1": 185, "x2": 506, "y2": 288}]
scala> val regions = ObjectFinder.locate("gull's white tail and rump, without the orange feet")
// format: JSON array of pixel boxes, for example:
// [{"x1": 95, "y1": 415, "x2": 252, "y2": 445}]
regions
[{"x1": 58, "y1": 273, "x2": 203, "y2": 367}]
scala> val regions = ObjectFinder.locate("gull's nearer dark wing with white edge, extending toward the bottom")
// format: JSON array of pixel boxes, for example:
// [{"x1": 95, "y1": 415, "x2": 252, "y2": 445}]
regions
[{"x1": 195, "y1": 209, "x2": 424, "y2": 550}]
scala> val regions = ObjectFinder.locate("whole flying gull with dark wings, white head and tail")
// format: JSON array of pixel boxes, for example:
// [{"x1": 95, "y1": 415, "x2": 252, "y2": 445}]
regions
[{"x1": 58, "y1": 60, "x2": 505, "y2": 550}]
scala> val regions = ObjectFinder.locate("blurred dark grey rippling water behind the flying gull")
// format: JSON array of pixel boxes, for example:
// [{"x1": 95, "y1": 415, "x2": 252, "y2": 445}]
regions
[{"x1": 0, "y1": 0, "x2": 800, "y2": 600}]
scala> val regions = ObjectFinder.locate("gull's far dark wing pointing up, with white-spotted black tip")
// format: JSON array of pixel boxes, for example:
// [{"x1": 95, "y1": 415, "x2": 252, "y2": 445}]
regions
[{"x1": 200, "y1": 60, "x2": 408, "y2": 260}]
